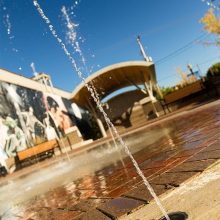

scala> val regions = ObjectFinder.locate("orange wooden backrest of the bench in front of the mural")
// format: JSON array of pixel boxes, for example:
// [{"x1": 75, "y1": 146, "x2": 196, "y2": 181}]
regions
[{"x1": 17, "y1": 139, "x2": 59, "y2": 161}]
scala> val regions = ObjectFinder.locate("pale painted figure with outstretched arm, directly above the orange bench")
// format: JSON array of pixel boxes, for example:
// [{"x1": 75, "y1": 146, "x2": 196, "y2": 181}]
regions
[{"x1": 21, "y1": 106, "x2": 45, "y2": 146}]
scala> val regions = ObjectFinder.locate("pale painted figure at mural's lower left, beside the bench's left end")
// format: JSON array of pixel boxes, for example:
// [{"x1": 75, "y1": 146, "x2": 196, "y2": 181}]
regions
[{"x1": 5, "y1": 116, "x2": 27, "y2": 157}]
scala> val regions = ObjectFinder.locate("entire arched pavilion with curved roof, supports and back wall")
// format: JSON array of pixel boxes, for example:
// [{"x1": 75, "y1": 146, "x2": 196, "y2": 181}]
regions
[{"x1": 71, "y1": 60, "x2": 161, "y2": 137}]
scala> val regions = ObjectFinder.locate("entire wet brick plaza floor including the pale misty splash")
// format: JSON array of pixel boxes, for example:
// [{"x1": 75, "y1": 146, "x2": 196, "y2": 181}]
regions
[{"x1": 0, "y1": 100, "x2": 220, "y2": 220}]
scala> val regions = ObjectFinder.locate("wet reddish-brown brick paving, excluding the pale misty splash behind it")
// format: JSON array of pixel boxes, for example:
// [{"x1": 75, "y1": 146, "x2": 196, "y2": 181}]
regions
[{"x1": 1, "y1": 101, "x2": 220, "y2": 220}]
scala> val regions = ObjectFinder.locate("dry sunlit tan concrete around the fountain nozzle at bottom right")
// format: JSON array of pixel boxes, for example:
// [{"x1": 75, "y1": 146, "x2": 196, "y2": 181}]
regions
[{"x1": 125, "y1": 160, "x2": 220, "y2": 220}]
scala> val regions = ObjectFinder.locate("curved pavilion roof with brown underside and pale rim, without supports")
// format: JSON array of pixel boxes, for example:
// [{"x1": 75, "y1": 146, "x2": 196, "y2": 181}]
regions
[{"x1": 71, "y1": 61, "x2": 156, "y2": 109}]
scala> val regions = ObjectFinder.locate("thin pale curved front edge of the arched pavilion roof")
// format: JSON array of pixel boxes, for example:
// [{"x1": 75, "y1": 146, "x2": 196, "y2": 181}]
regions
[{"x1": 71, "y1": 61, "x2": 154, "y2": 98}]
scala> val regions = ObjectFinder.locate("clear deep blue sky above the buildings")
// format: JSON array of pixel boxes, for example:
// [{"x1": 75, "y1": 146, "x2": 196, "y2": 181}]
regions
[{"x1": 0, "y1": 0, "x2": 220, "y2": 91}]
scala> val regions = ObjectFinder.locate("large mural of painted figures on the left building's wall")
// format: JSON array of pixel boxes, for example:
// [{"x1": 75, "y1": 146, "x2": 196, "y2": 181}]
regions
[{"x1": 0, "y1": 82, "x2": 78, "y2": 164}]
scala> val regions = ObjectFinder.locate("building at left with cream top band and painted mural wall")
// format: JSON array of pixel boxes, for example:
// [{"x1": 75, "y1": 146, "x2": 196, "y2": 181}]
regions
[{"x1": 0, "y1": 69, "x2": 84, "y2": 163}]
